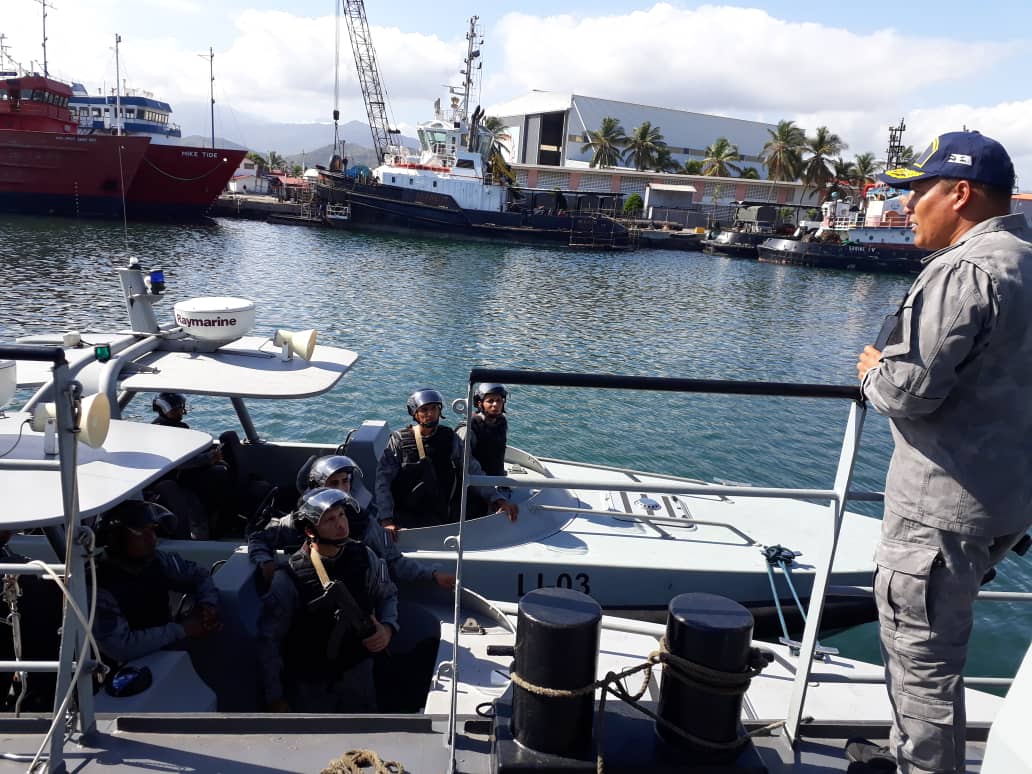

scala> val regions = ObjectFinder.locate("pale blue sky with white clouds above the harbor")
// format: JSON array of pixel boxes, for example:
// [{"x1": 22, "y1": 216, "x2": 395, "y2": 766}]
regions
[{"x1": 8, "y1": 0, "x2": 1032, "y2": 190}]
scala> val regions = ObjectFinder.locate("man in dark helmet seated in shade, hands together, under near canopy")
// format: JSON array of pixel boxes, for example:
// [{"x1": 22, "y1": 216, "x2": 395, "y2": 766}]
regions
[{"x1": 93, "y1": 499, "x2": 222, "y2": 664}]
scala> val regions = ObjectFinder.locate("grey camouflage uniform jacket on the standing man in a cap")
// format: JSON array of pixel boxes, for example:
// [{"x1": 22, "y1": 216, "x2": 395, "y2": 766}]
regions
[{"x1": 863, "y1": 214, "x2": 1032, "y2": 537}]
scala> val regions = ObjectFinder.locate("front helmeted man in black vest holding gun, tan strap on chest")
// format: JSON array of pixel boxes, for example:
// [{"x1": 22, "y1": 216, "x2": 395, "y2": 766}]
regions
[{"x1": 258, "y1": 487, "x2": 397, "y2": 712}]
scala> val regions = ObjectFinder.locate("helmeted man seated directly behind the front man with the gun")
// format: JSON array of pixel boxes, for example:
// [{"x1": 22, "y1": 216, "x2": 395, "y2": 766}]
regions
[{"x1": 248, "y1": 454, "x2": 455, "y2": 589}]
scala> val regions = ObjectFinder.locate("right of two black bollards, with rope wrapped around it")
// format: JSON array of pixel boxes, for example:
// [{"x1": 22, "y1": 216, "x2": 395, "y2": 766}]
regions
[{"x1": 656, "y1": 593, "x2": 752, "y2": 762}]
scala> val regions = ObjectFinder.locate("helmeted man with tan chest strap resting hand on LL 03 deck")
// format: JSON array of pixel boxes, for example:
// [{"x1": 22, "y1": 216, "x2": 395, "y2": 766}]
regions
[{"x1": 377, "y1": 389, "x2": 518, "y2": 539}]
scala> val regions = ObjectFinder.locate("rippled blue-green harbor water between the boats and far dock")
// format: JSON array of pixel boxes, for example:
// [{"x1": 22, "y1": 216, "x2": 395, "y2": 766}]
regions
[{"x1": 0, "y1": 216, "x2": 1032, "y2": 689}]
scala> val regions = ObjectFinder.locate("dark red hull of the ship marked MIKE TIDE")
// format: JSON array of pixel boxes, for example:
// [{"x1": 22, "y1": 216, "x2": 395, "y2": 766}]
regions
[{"x1": 126, "y1": 143, "x2": 247, "y2": 220}]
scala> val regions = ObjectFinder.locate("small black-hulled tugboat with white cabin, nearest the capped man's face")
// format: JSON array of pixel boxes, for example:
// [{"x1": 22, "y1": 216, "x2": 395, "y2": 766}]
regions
[{"x1": 759, "y1": 186, "x2": 930, "y2": 275}]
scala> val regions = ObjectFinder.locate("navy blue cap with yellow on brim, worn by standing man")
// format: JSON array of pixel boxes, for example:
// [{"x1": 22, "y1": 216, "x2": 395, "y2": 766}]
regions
[{"x1": 878, "y1": 132, "x2": 1014, "y2": 190}]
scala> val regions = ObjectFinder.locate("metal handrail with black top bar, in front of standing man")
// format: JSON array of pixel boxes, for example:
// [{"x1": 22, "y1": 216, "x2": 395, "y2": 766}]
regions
[{"x1": 450, "y1": 367, "x2": 881, "y2": 769}]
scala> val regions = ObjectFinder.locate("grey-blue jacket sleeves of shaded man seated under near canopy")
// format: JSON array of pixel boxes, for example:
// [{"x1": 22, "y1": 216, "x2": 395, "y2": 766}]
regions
[{"x1": 93, "y1": 551, "x2": 219, "y2": 664}]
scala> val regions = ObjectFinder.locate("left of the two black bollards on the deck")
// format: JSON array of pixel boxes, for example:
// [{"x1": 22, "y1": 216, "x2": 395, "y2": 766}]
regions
[{"x1": 512, "y1": 588, "x2": 602, "y2": 759}]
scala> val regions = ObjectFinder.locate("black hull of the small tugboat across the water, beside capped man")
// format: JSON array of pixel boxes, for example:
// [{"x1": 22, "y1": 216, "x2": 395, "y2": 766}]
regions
[{"x1": 759, "y1": 239, "x2": 928, "y2": 275}]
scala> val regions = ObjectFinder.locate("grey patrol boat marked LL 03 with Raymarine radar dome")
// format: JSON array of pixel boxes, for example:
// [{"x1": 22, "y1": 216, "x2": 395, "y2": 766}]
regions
[{"x1": 6, "y1": 258, "x2": 879, "y2": 640}]
